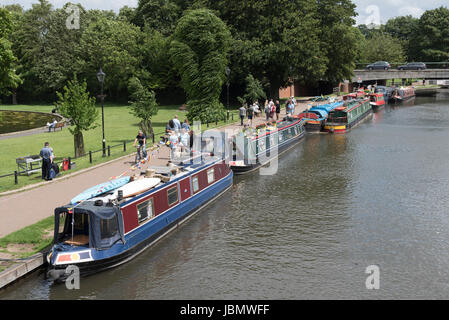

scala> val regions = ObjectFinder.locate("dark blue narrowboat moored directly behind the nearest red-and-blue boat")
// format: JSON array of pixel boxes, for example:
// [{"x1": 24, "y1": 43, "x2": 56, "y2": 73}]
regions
[{"x1": 229, "y1": 117, "x2": 306, "y2": 175}]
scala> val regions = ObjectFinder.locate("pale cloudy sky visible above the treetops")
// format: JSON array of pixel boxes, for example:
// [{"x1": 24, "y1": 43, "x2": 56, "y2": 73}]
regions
[{"x1": 0, "y1": 0, "x2": 449, "y2": 24}]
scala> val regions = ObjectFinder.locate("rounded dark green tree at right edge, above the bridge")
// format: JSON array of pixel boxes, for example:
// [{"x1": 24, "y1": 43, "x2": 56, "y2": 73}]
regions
[{"x1": 410, "y1": 7, "x2": 449, "y2": 62}]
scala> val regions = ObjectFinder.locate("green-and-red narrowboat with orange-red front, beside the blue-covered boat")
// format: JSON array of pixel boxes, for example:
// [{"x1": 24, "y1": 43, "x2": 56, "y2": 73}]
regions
[{"x1": 324, "y1": 99, "x2": 373, "y2": 133}]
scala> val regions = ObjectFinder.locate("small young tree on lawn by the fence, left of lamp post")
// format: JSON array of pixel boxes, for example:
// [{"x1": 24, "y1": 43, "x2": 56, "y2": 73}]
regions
[{"x1": 55, "y1": 75, "x2": 99, "y2": 157}]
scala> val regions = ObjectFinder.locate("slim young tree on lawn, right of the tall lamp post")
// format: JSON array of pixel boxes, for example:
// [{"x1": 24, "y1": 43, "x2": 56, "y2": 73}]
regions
[{"x1": 128, "y1": 77, "x2": 158, "y2": 137}]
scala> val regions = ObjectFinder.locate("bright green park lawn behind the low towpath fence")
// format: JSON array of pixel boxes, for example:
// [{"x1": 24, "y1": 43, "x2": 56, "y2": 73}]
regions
[{"x1": 0, "y1": 104, "x2": 238, "y2": 192}]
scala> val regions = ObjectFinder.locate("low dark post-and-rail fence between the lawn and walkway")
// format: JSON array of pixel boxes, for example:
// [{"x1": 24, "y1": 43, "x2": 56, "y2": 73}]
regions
[{"x1": 0, "y1": 113, "x2": 238, "y2": 189}]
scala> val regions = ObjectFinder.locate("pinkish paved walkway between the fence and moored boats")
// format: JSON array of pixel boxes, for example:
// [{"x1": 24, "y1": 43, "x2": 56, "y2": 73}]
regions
[{"x1": 0, "y1": 103, "x2": 307, "y2": 237}]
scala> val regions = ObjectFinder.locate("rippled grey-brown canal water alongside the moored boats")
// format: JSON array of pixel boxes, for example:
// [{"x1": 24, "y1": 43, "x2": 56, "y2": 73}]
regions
[{"x1": 0, "y1": 92, "x2": 449, "y2": 299}]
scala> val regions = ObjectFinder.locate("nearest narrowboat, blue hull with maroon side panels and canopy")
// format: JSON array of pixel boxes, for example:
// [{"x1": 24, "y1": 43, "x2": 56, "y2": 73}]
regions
[{"x1": 47, "y1": 147, "x2": 233, "y2": 282}]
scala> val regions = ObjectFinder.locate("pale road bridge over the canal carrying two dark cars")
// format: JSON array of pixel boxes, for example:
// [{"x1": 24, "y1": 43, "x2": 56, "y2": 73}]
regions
[{"x1": 352, "y1": 69, "x2": 449, "y2": 83}]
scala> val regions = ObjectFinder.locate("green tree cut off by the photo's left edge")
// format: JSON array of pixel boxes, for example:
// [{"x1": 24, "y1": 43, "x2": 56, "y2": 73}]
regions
[{"x1": 0, "y1": 8, "x2": 21, "y2": 95}]
